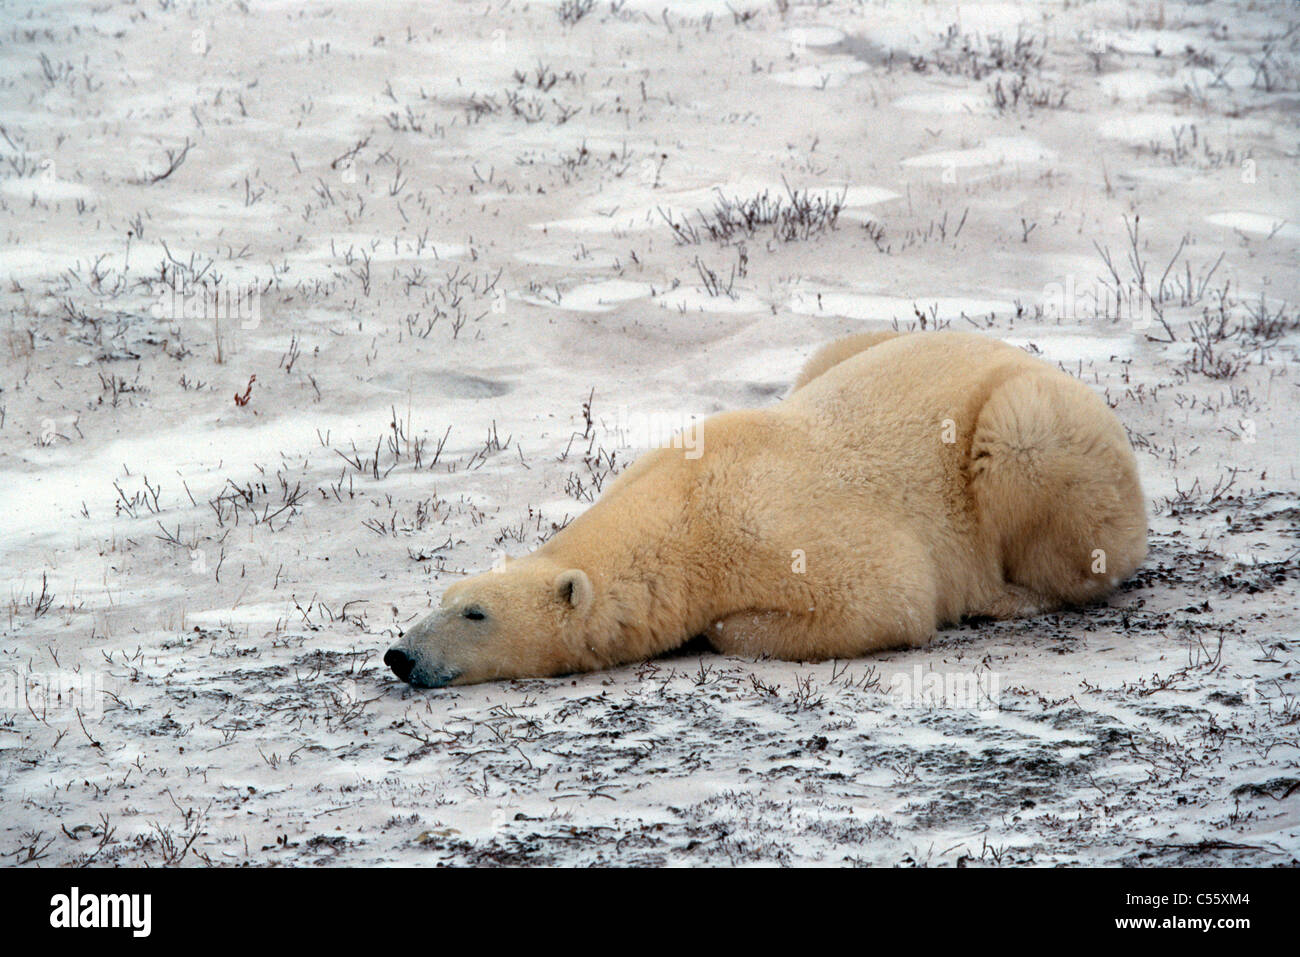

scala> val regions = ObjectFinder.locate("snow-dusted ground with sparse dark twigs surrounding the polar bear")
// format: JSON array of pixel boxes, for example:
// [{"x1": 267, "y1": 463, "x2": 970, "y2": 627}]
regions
[{"x1": 0, "y1": 0, "x2": 1300, "y2": 865}]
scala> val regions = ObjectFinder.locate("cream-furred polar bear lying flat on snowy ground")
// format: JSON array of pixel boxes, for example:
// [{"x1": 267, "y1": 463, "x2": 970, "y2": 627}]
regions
[{"x1": 384, "y1": 332, "x2": 1147, "y2": 688}]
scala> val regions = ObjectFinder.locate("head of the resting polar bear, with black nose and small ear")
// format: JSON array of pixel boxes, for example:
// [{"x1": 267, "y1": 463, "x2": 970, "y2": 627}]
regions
[{"x1": 384, "y1": 554, "x2": 595, "y2": 688}]
